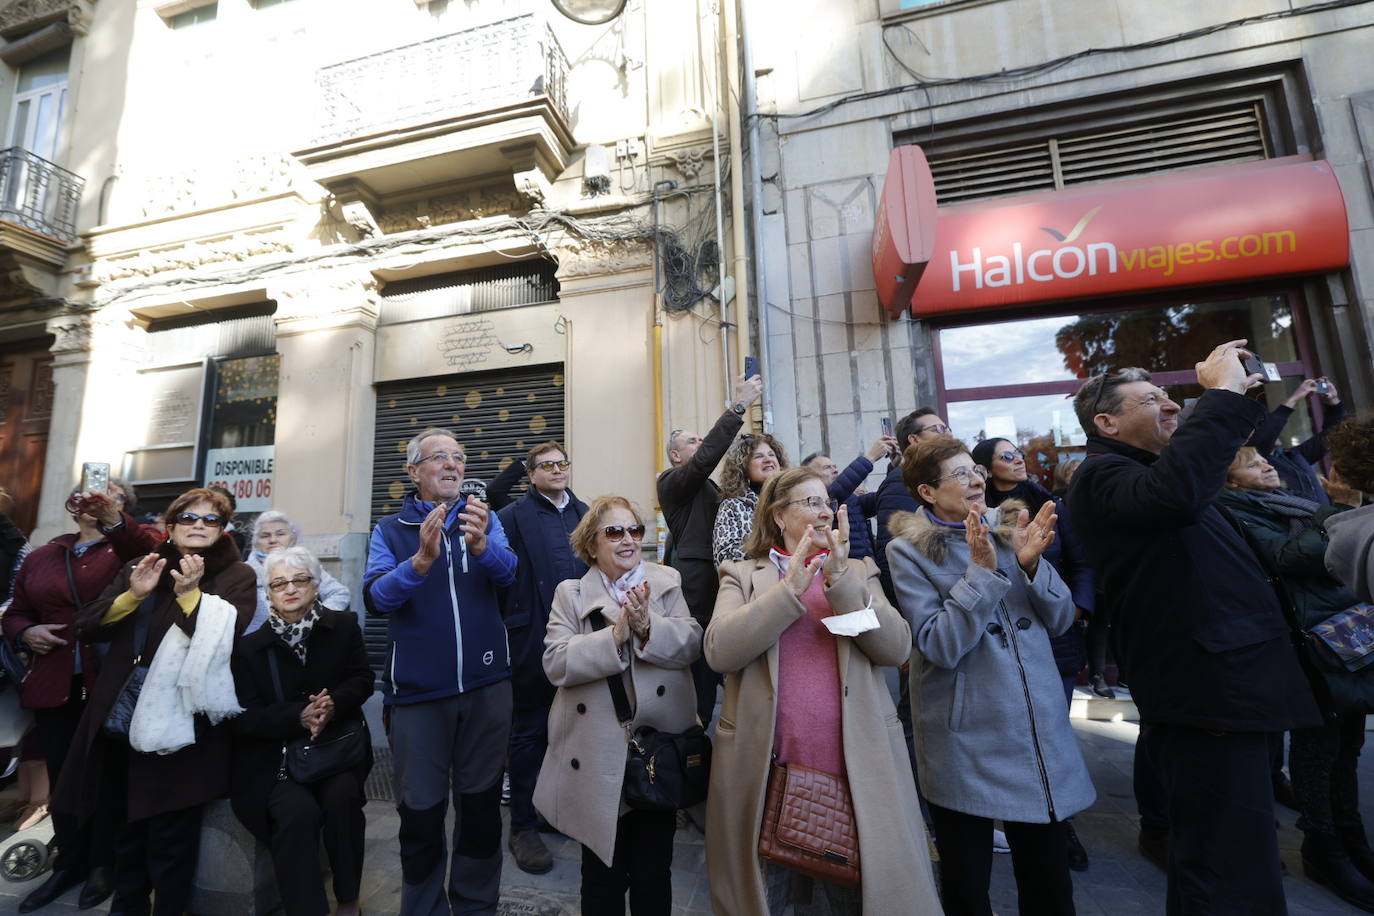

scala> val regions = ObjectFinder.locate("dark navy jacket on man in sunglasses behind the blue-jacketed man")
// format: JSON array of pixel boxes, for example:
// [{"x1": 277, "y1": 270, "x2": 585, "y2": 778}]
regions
[{"x1": 497, "y1": 488, "x2": 587, "y2": 683}]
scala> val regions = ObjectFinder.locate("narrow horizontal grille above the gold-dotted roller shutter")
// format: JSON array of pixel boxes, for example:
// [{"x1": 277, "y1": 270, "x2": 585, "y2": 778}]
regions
[{"x1": 378, "y1": 260, "x2": 558, "y2": 324}]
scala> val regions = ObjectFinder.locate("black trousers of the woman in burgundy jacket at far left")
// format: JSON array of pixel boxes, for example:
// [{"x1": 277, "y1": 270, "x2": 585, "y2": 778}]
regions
[{"x1": 33, "y1": 674, "x2": 121, "y2": 875}]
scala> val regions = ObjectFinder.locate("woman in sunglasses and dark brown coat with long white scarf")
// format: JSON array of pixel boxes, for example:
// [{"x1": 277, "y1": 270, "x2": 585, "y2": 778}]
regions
[{"x1": 54, "y1": 488, "x2": 257, "y2": 916}]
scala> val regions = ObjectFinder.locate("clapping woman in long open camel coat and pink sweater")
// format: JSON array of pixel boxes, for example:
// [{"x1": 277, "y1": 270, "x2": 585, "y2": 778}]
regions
[{"x1": 705, "y1": 467, "x2": 941, "y2": 916}]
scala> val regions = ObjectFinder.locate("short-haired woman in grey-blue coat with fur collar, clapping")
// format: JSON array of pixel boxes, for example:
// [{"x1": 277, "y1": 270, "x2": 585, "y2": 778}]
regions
[{"x1": 888, "y1": 435, "x2": 1094, "y2": 916}]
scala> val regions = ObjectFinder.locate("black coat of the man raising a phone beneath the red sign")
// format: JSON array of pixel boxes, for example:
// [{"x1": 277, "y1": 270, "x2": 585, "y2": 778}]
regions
[{"x1": 1069, "y1": 389, "x2": 1320, "y2": 732}]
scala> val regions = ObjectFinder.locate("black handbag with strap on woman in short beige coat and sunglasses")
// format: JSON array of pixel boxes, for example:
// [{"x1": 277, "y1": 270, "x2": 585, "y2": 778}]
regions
[{"x1": 591, "y1": 611, "x2": 710, "y2": 812}]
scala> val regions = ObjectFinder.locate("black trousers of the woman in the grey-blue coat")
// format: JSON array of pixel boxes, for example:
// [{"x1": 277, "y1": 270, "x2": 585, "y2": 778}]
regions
[{"x1": 930, "y1": 803, "x2": 1074, "y2": 916}]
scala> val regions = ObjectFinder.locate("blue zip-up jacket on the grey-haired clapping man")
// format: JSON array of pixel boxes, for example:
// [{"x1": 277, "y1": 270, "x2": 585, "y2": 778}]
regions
[{"x1": 363, "y1": 493, "x2": 517, "y2": 705}]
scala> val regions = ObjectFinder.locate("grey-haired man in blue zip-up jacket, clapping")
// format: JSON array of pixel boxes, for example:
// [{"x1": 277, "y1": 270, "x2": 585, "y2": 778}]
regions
[{"x1": 363, "y1": 428, "x2": 517, "y2": 916}]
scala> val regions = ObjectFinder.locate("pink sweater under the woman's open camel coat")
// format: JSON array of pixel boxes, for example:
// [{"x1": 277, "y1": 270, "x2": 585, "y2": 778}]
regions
[{"x1": 774, "y1": 574, "x2": 845, "y2": 776}]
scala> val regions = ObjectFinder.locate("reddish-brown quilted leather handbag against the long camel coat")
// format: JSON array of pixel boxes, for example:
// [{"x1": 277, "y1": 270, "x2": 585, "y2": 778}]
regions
[{"x1": 758, "y1": 764, "x2": 859, "y2": 887}]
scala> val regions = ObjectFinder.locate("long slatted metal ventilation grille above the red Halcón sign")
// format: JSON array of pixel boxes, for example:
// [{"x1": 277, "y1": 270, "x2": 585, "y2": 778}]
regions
[{"x1": 927, "y1": 100, "x2": 1272, "y2": 205}]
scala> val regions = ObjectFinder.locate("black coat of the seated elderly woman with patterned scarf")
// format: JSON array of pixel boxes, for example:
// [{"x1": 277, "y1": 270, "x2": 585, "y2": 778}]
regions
[{"x1": 229, "y1": 606, "x2": 375, "y2": 843}]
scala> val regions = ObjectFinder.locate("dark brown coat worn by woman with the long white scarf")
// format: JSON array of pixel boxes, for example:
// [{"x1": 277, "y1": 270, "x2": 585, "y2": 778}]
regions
[{"x1": 52, "y1": 536, "x2": 257, "y2": 820}]
